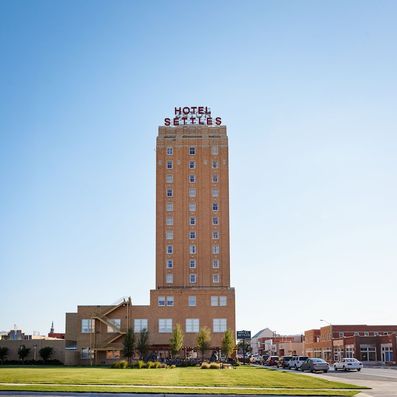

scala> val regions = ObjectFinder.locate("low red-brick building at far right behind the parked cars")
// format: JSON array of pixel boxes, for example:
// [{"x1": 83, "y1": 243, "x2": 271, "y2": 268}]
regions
[{"x1": 304, "y1": 324, "x2": 397, "y2": 365}]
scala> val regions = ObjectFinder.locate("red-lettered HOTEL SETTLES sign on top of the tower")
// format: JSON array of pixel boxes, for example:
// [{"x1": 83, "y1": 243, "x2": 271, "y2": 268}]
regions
[{"x1": 164, "y1": 106, "x2": 222, "y2": 127}]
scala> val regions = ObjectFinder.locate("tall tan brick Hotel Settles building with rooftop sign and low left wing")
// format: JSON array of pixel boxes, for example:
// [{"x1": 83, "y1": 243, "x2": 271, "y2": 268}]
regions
[{"x1": 66, "y1": 106, "x2": 235, "y2": 364}]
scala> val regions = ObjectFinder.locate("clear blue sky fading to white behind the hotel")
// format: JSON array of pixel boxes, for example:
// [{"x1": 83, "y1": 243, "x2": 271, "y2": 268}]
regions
[{"x1": 0, "y1": 0, "x2": 397, "y2": 333}]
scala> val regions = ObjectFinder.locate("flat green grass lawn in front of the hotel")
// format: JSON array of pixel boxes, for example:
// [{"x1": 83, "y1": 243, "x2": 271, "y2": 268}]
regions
[{"x1": 0, "y1": 367, "x2": 366, "y2": 396}]
